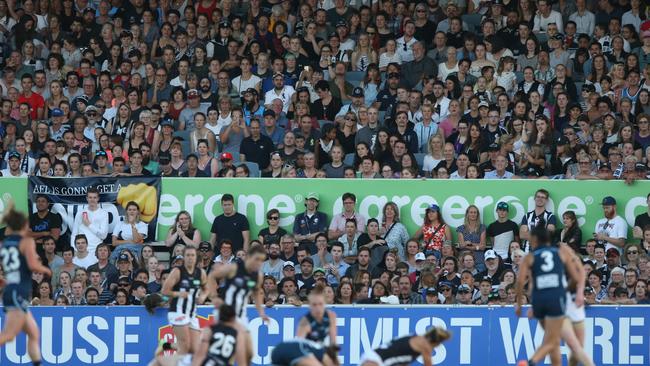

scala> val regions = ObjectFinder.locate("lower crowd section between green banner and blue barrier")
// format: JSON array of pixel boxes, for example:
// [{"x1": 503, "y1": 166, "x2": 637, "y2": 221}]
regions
[{"x1": 5, "y1": 188, "x2": 650, "y2": 306}]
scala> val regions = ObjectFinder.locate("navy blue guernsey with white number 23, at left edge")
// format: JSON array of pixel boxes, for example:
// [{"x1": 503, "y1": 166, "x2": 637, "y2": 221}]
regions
[{"x1": 0, "y1": 235, "x2": 32, "y2": 294}]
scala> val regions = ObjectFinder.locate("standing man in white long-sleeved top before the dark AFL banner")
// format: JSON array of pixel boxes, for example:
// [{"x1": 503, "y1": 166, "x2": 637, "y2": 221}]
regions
[{"x1": 70, "y1": 187, "x2": 108, "y2": 257}]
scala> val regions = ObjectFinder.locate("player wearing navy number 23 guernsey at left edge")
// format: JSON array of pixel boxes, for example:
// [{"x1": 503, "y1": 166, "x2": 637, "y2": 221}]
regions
[{"x1": 0, "y1": 204, "x2": 52, "y2": 366}]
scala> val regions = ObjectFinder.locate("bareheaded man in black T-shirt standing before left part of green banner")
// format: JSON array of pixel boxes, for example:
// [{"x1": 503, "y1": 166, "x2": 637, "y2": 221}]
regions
[{"x1": 210, "y1": 193, "x2": 250, "y2": 253}]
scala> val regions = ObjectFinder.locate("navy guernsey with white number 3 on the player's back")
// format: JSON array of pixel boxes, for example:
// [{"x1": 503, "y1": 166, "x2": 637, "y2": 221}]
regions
[{"x1": 532, "y1": 247, "x2": 567, "y2": 301}]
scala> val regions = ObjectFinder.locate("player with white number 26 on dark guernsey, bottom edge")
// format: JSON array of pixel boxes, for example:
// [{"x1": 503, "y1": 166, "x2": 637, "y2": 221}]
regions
[{"x1": 192, "y1": 304, "x2": 248, "y2": 366}]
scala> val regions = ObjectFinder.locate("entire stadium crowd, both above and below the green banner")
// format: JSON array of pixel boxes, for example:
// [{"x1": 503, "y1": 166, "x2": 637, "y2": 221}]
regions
[{"x1": 0, "y1": 0, "x2": 650, "y2": 306}]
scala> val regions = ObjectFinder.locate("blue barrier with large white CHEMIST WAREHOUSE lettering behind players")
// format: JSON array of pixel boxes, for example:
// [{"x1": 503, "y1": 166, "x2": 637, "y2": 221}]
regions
[{"x1": 0, "y1": 306, "x2": 650, "y2": 366}]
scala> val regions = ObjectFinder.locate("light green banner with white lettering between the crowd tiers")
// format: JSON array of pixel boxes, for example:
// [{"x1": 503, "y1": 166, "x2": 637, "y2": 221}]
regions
[{"x1": 0, "y1": 178, "x2": 650, "y2": 240}]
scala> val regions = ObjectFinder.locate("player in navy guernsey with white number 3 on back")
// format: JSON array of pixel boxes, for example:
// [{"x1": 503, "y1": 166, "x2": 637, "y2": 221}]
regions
[{"x1": 515, "y1": 227, "x2": 584, "y2": 366}]
